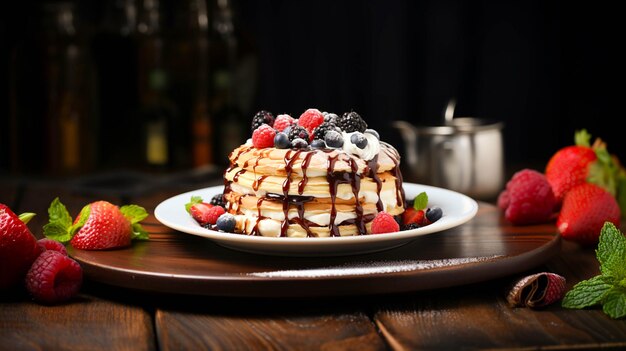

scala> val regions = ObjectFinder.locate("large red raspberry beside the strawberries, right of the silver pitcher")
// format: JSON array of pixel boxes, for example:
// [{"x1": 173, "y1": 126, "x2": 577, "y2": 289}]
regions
[{"x1": 500, "y1": 169, "x2": 557, "y2": 224}]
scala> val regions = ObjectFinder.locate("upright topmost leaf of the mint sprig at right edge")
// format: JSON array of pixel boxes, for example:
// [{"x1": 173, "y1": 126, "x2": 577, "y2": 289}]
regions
[{"x1": 596, "y1": 222, "x2": 626, "y2": 280}]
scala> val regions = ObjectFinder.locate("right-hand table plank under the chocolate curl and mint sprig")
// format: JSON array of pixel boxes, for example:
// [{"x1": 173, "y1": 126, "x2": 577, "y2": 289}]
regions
[{"x1": 374, "y1": 235, "x2": 626, "y2": 349}]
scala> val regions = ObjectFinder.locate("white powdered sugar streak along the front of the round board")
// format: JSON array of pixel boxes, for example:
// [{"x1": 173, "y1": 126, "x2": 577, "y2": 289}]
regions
[{"x1": 247, "y1": 255, "x2": 502, "y2": 278}]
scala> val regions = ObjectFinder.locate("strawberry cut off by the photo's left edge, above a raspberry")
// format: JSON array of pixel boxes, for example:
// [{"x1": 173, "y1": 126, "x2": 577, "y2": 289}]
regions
[{"x1": 0, "y1": 204, "x2": 41, "y2": 290}]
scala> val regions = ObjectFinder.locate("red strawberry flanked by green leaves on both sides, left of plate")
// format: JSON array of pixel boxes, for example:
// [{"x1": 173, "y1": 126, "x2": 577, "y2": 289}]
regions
[{"x1": 44, "y1": 198, "x2": 148, "y2": 250}]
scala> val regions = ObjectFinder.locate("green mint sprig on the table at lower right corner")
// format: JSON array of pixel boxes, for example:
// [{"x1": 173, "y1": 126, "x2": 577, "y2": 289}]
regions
[{"x1": 561, "y1": 222, "x2": 626, "y2": 319}]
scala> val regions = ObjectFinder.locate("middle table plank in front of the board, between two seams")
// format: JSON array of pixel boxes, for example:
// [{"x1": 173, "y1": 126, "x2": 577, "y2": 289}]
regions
[{"x1": 156, "y1": 301, "x2": 386, "y2": 351}]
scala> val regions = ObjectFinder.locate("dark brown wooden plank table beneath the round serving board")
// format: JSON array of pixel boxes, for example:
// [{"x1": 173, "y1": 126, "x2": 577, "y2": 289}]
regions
[{"x1": 0, "y1": 175, "x2": 626, "y2": 351}]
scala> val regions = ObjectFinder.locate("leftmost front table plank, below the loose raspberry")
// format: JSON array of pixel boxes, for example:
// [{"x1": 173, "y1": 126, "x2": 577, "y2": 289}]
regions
[{"x1": 0, "y1": 294, "x2": 156, "y2": 351}]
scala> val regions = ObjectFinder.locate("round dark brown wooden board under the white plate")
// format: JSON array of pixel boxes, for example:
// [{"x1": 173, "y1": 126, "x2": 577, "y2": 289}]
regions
[{"x1": 68, "y1": 203, "x2": 560, "y2": 297}]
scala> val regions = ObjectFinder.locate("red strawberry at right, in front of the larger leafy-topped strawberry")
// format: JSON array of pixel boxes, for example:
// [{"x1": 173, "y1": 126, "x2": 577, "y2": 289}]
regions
[{"x1": 556, "y1": 183, "x2": 620, "y2": 245}]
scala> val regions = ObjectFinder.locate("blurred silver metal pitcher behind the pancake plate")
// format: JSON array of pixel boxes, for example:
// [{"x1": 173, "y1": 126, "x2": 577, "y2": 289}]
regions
[{"x1": 393, "y1": 101, "x2": 505, "y2": 200}]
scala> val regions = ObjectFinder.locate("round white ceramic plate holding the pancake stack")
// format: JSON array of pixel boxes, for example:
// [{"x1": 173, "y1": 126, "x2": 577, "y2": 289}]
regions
[{"x1": 154, "y1": 183, "x2": 478, "y2": 256}]
